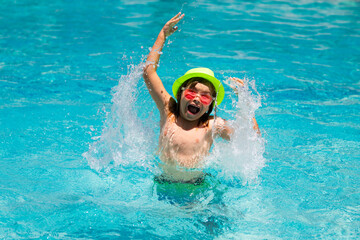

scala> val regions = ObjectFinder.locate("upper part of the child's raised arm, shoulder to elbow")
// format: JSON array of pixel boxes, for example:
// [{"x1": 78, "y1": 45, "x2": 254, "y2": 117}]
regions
[{"x1": 143, "y1": 65, "x2": 171, "y2": 114}]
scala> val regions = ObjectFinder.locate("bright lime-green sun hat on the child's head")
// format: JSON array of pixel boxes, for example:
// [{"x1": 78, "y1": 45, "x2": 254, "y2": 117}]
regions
[{"x1": 172, "y1": 68, "x2": 225, "y2": 105}]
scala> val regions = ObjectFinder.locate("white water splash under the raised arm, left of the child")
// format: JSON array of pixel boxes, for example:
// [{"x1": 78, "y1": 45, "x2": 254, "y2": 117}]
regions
[{"x1": 83, "y1": 62, "x2": 155, "y2": 172}]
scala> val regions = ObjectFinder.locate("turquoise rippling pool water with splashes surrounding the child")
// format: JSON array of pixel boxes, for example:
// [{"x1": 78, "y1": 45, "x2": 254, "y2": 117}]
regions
[{"x1": 0, "y1": 0, "x2": 360, "y2": 239}]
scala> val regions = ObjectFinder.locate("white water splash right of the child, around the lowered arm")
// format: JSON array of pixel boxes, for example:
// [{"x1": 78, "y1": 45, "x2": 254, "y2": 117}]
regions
[{"x1": 209, "y1": 79, "x2": 265, "y2": 184}]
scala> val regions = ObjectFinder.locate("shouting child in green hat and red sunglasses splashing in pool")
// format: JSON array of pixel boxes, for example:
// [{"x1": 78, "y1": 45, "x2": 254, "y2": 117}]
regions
[{"x1": 143, "y1": 13, "x2": 257, "y2": 183}]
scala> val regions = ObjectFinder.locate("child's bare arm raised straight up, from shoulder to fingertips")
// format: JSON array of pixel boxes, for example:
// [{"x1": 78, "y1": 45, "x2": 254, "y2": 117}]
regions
[{"x1": 143, "y1": 13, "x2": 184, "y2": 115}]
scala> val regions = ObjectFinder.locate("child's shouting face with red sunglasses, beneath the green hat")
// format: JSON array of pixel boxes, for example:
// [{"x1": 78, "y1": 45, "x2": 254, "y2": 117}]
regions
[{"x1": 180, "y1": 83, "x2": 213, "y2": 121}]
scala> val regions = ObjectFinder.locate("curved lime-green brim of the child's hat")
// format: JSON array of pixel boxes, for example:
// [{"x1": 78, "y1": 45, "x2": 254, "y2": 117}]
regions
[{"x1": 172, "y1": 73, "x2": 225, "y2": 105}]
